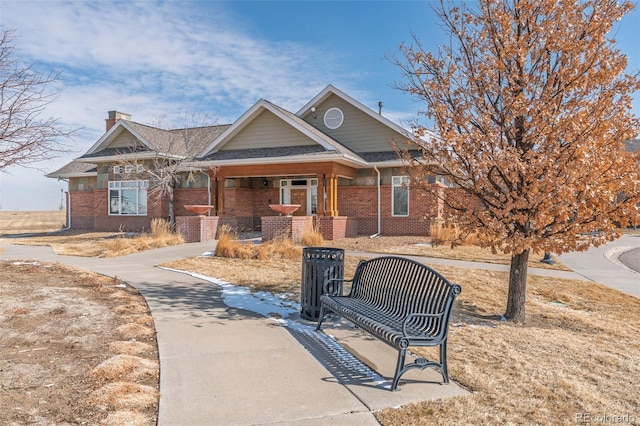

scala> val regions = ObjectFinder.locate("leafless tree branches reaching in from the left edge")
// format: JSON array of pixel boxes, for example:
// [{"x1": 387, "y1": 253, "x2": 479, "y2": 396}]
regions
[{"x1": 0, "y1": 29, "x2": 73, "y2": 170}]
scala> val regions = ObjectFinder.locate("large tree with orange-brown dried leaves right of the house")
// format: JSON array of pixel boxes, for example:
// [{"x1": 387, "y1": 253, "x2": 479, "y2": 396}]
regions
[{"x1": 394, "y1": 0, "x2": 640, "y2": 323}]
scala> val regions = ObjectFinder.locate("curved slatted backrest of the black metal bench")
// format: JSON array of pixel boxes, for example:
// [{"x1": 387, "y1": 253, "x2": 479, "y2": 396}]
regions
[{"x1": 351, "y1": 256, "x2": 460, "y2": 334}]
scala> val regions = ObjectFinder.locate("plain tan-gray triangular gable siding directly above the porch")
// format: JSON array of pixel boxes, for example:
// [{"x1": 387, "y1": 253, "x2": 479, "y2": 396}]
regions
[{"x1": 220, "y1": 110, "x2": 317, "y2": 151}]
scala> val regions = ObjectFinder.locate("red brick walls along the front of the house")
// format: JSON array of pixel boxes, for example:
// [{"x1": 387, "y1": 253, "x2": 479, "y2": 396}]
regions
[{"x1": 65, "y1": 181, "x2": 445, "y2": 240}]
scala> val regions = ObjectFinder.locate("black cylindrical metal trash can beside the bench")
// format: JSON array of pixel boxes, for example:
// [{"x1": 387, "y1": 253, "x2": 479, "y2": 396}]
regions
[{"x1": 300, "y1": 247, "x2": 344, "y2": 321}]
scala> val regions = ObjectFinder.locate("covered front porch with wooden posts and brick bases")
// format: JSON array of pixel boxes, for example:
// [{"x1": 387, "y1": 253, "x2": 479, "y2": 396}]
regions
[{"x1": 208, "y1": 162, "x2": 357, "y2": 241}]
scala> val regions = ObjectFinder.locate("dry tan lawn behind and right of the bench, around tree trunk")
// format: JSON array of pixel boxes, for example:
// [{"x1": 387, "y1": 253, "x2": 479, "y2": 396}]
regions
[{"x1": 164, "y1": 256, "x2": 640, "y2": 425}]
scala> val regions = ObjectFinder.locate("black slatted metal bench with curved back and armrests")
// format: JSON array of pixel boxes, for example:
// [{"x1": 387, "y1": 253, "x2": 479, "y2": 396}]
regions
[{"x1": 316, "y1": 256, "x2": 461, "y2": 391}]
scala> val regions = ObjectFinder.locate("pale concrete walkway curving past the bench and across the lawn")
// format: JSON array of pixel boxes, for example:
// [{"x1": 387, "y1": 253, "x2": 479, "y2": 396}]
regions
[{"x1": 0, "y1": 236, "x2": 640, "y2": 426}]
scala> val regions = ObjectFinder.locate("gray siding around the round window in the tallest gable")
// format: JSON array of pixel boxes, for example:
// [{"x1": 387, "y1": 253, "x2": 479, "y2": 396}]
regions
[{"x1": 303, "y1": 95, "x2": 406, "y2": 153}]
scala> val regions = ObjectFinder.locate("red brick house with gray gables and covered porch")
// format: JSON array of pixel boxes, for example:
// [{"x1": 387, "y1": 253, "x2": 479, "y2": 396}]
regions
[{"x1": 47, "y1": 85, "x2": 446, "y2": 239}]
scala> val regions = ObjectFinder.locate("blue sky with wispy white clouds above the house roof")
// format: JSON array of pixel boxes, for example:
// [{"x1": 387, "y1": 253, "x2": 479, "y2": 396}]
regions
[{"x1": 0, "y1": 0, "x2": 640, "y2": 210}]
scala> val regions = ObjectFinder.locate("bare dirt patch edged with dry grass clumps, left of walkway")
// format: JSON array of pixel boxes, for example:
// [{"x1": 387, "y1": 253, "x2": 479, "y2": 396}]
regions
[{"x1": 0, "y1": 262, "x2": 159, "y2": 425}]
